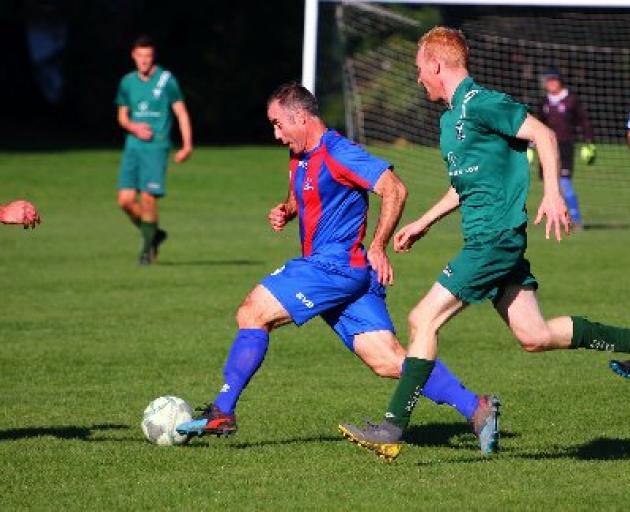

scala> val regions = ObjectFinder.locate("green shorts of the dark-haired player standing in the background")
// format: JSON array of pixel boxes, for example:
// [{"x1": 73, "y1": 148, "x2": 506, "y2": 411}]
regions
[{"x1": 118, "y1": 148, "x2": 169, "y2": 197}]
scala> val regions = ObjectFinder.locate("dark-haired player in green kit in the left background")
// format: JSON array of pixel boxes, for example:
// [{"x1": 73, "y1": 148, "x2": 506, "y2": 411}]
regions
[{"x1": 116, "y1": 36, "x2": 192, "y2": 265}]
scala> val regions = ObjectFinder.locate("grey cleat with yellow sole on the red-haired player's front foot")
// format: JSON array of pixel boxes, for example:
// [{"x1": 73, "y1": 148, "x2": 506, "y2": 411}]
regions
[{"x1": 339, "y1": 420, "x2": 402, "y2": 462}]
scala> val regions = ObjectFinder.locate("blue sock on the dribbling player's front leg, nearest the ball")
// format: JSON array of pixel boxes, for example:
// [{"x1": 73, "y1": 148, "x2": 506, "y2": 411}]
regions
[{"x1": 214, "y1": 329, "x2": 269, "y2": 414}]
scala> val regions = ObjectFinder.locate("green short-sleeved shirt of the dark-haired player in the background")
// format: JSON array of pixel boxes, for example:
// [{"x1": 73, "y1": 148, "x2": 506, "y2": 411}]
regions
[{"x1": 116, "y1": 66, "x2": 183, "y2": 149}]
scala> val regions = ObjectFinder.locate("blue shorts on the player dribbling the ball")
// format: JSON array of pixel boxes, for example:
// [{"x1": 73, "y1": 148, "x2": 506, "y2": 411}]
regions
[{"x1": 260, "y1": 258, "x2": 396, "y2": 351}]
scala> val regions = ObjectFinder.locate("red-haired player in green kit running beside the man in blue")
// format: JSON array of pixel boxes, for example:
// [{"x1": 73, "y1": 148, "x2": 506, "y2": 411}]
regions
[{"x1": 339, "y1": 27, "x2": 630, "y2": 460}]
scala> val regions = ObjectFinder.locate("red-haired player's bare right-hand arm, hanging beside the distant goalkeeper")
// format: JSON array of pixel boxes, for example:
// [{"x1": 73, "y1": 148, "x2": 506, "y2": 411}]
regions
[{"x1": 516, "y1": 114, "x2": 571, "y2": 241}]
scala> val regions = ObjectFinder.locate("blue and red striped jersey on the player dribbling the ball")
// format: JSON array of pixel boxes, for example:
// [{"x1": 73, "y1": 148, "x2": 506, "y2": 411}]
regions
[{"x1": 289, "y1": 130, "x2": 391, "y2": 267}]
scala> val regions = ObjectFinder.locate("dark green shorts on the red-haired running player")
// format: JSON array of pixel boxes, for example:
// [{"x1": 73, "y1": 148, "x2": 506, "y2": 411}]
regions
[{"x1": 438, "y1": 226, "x2": 538, "y2": 304}]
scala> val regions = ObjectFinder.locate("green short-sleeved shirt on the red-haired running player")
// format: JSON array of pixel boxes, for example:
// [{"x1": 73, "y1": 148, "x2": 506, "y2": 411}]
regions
[{"x1": 440, "y1": 77, "x2": 529, "y2": 240}]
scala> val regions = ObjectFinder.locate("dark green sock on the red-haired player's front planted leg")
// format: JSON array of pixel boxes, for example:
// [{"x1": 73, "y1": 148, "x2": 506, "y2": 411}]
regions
[{"x1": 385, "y1": 357, "x2": 435, "y2": 430}]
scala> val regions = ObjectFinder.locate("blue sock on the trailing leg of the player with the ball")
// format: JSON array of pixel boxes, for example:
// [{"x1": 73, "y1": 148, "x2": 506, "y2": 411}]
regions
[{"x1": 422, "y1": 359, "x2": 479, "y2": 421}]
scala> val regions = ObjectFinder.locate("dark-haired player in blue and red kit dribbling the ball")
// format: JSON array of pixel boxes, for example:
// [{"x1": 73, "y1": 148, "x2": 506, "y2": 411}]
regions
[{"x1": 177, "y1": 83, "x2": 499, "y2": 452}]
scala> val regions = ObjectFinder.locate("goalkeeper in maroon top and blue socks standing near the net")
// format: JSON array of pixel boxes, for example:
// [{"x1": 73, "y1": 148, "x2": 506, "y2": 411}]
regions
[{"x1": 538, "y1": 68, "x2": 595, "y2": 229}]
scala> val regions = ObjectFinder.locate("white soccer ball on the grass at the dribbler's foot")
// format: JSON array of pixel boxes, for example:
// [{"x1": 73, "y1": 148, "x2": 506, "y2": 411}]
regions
[{"x1": 141, "y1": 396, "x2": 193, "y2": 446}]
